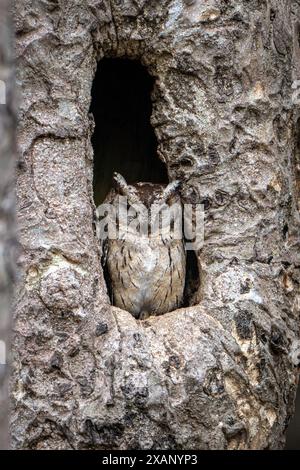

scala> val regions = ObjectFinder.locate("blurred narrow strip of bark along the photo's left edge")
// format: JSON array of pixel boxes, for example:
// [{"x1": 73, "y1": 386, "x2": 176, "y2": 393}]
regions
[{"x1": 0, "y1": 0, "x2": 16, "y2": 449}]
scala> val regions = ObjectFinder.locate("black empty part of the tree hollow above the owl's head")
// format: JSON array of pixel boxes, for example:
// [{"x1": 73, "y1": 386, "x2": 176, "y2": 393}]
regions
[{"x1": 91, "y1": 59, "x2": 168, "y2": 205}]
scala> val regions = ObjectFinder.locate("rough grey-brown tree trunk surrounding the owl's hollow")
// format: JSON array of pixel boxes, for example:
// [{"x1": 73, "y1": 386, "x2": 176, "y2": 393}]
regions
[{"x1": 12, "y1": 0, "x2": 300, "y2": 449}]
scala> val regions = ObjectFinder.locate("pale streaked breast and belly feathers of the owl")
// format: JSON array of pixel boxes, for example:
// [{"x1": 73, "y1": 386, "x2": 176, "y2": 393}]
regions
[{"x1": 107, "y1": 238, "x2": 186, "y2": 318}]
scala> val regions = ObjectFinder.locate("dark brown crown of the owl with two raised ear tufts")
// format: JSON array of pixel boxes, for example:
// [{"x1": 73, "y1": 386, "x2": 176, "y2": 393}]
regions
[{"x1": 113, "y1": 173, "x2": 180, "y2": 209}]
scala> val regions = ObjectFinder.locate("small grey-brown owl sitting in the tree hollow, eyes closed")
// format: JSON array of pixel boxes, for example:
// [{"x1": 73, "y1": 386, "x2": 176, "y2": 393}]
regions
[{"x1": 98, "y1": 173, "x2": 186, "y2": 320}]
